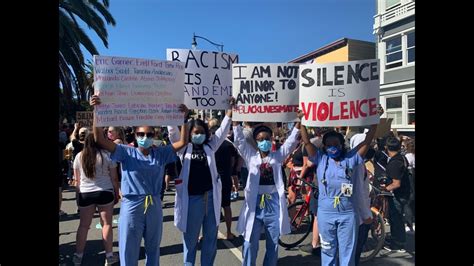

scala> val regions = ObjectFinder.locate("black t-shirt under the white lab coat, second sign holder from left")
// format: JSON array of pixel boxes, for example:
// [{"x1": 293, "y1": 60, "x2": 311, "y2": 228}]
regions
[{"x1": 188, "y1": 144, "x2": 212, "y2": 195}]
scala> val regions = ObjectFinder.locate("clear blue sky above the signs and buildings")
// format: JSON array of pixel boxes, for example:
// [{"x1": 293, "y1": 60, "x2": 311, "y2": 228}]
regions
[{"x1": 84, "y1": 0, "x2": 376, "y2": 63}]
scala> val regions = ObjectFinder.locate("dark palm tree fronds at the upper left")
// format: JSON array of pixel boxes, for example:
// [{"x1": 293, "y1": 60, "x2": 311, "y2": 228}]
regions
[{"x1": 58, "y1": 0, "x2": 116, "y2": 116}]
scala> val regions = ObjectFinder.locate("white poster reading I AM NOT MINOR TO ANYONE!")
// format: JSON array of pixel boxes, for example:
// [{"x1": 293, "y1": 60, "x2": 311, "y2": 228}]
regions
[{"x1": 232, "y1": 64, "x2": 299, "y2": 122}]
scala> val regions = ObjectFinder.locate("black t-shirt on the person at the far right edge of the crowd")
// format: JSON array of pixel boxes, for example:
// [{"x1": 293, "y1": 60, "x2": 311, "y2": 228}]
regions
[{"x1": 386, "y1": 153, "x2": 410, "y2": 199}]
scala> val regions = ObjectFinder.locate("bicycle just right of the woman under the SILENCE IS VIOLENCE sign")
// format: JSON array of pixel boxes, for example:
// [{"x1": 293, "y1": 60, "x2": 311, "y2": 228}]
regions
[{"x1": 360, "y1": 180, "x2": 394, "y2": 262}]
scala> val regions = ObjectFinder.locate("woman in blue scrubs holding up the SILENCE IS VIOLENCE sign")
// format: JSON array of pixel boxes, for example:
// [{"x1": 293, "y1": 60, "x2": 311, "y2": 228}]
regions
[{"x1": 301, "y1": 121, "x2": 377, "y2": 266}]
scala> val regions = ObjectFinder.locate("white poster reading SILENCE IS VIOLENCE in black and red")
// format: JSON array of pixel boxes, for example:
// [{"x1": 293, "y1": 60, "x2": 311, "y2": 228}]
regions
[{"x1": 299, "y1": 59, "x2": 380, "y2": 127}]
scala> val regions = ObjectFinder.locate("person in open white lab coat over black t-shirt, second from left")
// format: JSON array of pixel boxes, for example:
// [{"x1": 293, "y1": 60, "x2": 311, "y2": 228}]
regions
[{"x1": 168, "y1": 100, "x2": 233, "y2": 266}]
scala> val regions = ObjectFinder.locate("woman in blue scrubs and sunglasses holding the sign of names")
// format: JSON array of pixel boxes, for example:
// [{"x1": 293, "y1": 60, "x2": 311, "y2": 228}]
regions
[{"x1": 91, "y1": 95, "x2": 188, "y2": 266}]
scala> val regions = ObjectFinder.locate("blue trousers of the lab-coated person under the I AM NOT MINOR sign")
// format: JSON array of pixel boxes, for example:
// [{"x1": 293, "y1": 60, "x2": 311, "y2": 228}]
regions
[{"x1": 242, "y1": 192, "x2": 280, "y2": 266}]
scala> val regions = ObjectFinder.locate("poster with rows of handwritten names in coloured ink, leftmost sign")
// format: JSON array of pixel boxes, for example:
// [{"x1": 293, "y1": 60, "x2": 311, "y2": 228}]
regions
[{"x1": 94, "y1": 55, "x2": 184, "y2": 126}]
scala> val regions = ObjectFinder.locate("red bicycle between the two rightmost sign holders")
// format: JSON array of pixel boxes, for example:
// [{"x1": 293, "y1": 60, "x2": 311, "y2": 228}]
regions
[{"x1": 278, "y1": 177, "x2": 318, "y2": 249}]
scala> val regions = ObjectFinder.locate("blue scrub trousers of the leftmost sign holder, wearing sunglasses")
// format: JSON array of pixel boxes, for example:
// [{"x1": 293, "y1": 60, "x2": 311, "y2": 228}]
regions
[{"x1": 118, "y1": 195, "x2": 163, "y2": 266}]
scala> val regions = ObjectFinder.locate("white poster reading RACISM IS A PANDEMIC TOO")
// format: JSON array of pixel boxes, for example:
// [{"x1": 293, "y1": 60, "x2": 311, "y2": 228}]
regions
[{"x1": 166, "y1": 48, "x2": 239, "y2": 110}]
